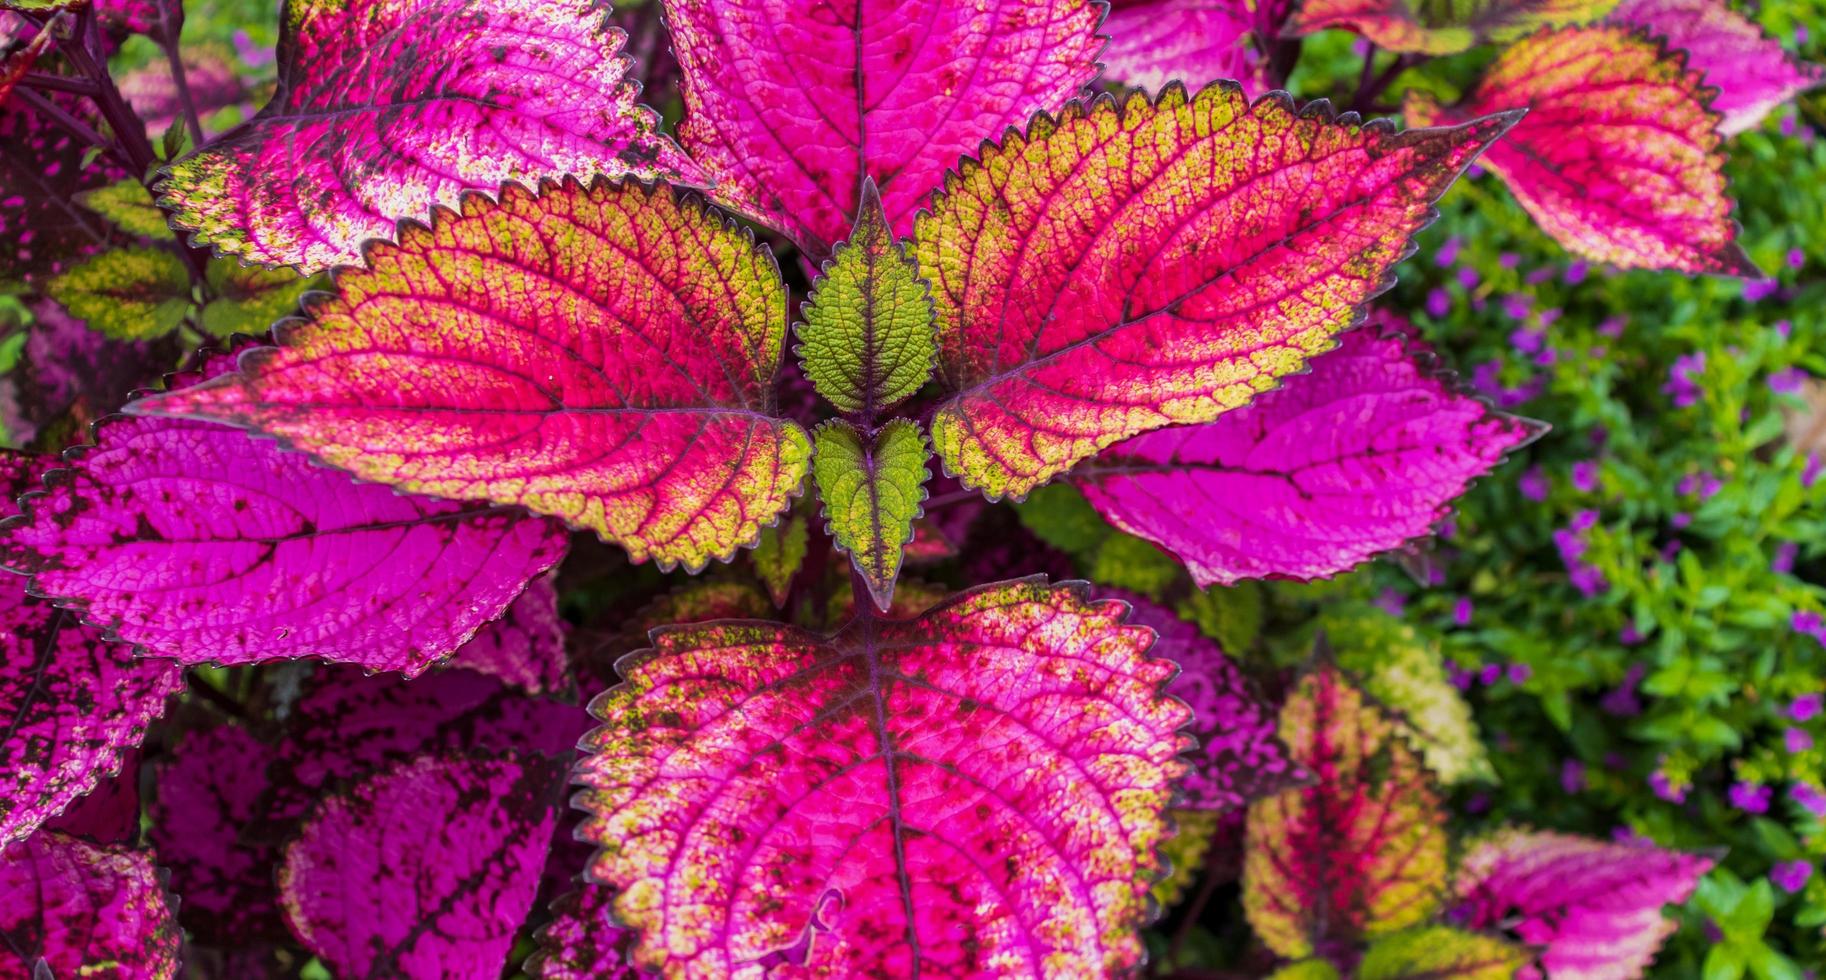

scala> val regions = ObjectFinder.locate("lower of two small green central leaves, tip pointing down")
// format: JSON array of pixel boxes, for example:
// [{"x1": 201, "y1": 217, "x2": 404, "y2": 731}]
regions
[{"x1": 811, "y1": 418, "x2": 931, "y2": 611}]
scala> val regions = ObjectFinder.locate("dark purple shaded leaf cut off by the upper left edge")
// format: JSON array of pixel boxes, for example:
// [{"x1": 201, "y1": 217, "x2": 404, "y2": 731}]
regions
[{"x1": 0, "y1": 93, "x2": 128, "y2": 279}]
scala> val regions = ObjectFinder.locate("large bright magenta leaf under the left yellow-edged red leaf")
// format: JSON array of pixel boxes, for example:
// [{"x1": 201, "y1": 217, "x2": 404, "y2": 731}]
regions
[{"x1": 0, "y1": 356, "x2": 564, "y2": 673}]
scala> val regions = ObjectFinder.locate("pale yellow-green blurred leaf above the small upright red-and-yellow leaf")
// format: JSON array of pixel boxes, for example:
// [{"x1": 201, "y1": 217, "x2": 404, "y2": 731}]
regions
[{"x1": 1320, "y1": 606, "x2": 1495, "y2": 785}]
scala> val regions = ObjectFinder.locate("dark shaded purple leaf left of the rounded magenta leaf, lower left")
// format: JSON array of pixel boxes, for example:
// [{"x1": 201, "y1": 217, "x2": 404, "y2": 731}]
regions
[{"x1": 152, "y1": 722, "x2": 285, "y2": 947}]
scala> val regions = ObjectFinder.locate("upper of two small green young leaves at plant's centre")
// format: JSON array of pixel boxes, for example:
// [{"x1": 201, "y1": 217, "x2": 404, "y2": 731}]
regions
[{"x1": 796, "y1": 181, "x2": 939, "y2": 412}]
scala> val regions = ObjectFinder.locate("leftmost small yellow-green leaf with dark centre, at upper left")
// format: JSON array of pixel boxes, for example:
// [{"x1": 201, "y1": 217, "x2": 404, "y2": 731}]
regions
[{"x1": 46, "y1": 248, "x2": 190, "y2": 339}]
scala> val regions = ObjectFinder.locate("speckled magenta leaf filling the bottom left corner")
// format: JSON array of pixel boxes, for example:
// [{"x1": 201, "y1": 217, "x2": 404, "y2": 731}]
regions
[{"x1": 0, "y1": 832, "x2": 183, "y2": 980}]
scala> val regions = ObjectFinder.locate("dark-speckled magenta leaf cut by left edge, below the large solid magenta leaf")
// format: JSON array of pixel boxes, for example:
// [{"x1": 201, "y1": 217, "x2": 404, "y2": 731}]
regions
[{"x1": 0, "y1": 451, "x2": 184, "y2": 847}]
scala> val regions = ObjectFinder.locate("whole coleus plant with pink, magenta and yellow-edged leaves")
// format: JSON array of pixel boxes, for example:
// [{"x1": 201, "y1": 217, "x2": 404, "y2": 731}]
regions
[{"x1": 0, "y1": 0, "x2": 1815, "y2": 978}]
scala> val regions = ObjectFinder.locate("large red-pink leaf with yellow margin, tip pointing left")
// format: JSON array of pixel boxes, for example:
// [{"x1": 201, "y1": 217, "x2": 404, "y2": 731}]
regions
[{"x1": 130, "y1": 181, "x2": 811, "y2": 569}]
